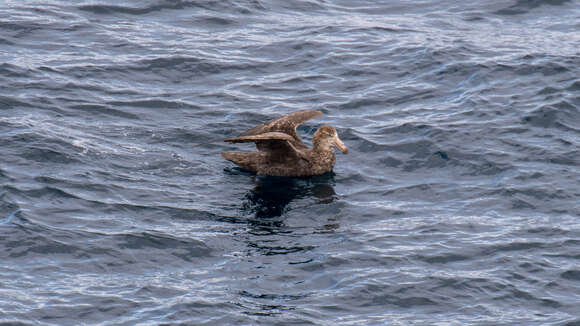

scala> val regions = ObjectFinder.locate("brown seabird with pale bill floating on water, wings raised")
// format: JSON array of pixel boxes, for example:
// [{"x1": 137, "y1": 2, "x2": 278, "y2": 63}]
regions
[{"x1": 222, "y1": 110, "x2": 348, "y2": 177}]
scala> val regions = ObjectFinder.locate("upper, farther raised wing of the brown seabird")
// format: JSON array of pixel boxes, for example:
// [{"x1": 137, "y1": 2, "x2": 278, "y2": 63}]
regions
[{"x1": 240, "y1": 110, "x2": 322, "y2": 147}]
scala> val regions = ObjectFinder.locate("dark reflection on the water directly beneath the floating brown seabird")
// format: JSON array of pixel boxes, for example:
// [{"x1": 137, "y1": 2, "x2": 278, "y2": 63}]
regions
[{"x1": 242, "y1": 173, "x2": 336, "y2": 223}]
